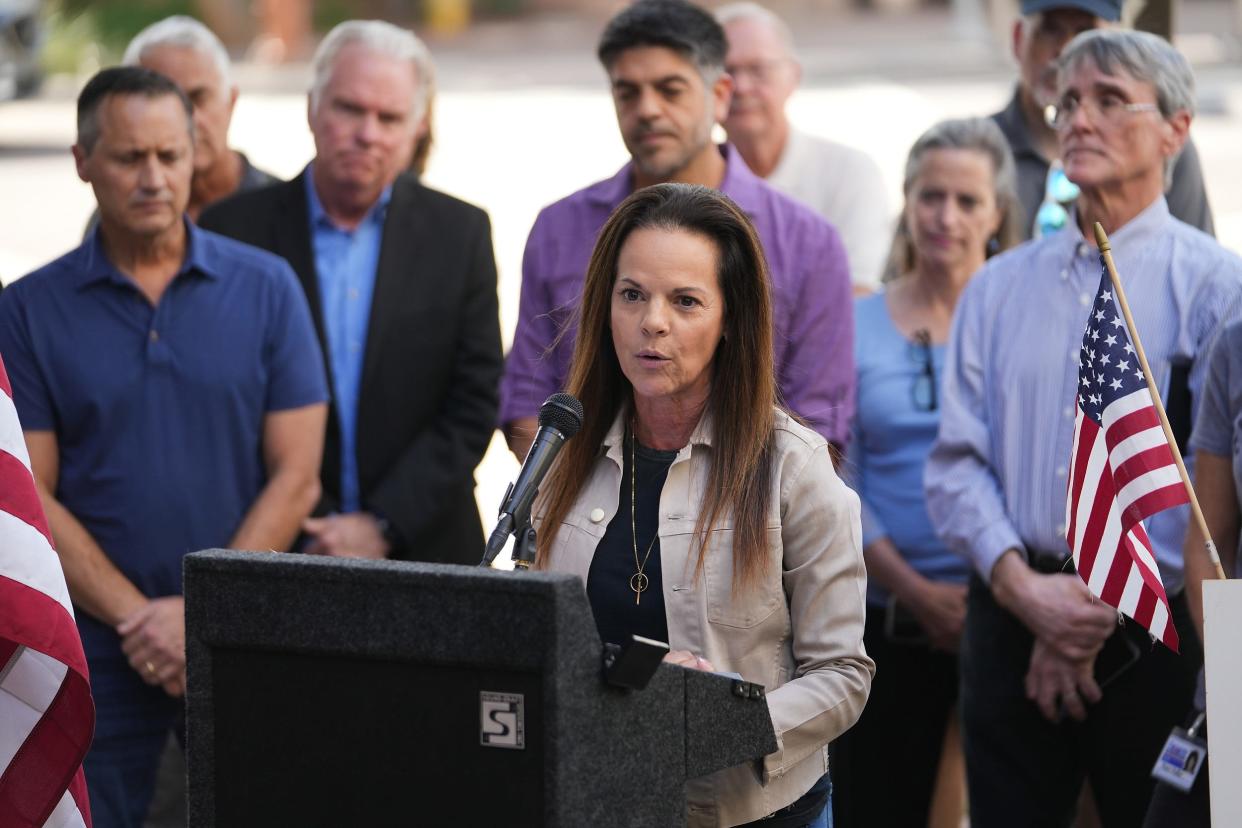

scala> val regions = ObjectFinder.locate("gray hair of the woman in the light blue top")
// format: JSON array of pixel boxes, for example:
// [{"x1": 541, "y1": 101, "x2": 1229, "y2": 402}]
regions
[{"x1": 883, "y1": 118, "x2": 1022, "y2": 282}]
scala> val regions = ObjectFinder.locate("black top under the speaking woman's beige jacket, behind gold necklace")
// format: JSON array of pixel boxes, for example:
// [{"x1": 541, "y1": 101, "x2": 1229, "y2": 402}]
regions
[{"x1": 586, "y1": 437, "x2": 677, "y2": 644}]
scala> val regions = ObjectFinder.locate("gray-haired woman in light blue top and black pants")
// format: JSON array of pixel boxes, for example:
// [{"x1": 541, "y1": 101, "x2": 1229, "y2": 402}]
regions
[{"x1": 832, "y1": 118, "x2": 1020, "y2": 828}]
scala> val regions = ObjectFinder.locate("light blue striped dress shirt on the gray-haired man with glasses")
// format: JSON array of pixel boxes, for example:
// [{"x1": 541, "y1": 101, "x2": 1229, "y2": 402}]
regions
[{"x1": 924, "y1": 196, "x2": 1242, "y2": 592}]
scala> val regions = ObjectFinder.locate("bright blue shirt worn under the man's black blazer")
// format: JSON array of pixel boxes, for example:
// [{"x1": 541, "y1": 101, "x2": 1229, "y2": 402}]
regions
[{"x1": 303, "y1": 165, "x2": 392, "y2": 513}]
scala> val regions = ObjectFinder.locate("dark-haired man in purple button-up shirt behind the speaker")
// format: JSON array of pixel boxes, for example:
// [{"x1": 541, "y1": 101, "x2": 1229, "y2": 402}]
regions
[{"x1": 501, "y1": 0, "x2": 853, "y2": 458}]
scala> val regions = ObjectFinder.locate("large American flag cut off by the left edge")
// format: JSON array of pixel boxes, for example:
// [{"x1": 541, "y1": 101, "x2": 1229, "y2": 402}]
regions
[{"x1": 0, "y1": 361, "x2": 94, "y2": 828}]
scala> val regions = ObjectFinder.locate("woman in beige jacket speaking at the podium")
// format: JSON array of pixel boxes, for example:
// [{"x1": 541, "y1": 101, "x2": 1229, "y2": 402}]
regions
[{"x1": 537, "y1": 184, "x2": 874, "y2": 828}]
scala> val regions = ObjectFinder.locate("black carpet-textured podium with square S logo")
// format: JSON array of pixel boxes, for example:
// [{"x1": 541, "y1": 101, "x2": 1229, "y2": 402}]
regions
[{"x1": 185, "y1": 550, "x2": 776, "y2": 828}]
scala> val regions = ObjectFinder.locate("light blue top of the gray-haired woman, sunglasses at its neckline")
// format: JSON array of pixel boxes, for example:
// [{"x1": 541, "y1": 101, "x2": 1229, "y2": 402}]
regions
[{"x1": 847, "y1": 293, "x2": 970, "y2": 605}]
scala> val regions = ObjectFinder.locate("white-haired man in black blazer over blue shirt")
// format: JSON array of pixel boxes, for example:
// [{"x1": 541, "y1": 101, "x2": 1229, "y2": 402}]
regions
[{"x1": 200, "y1": 21, "x2": 503, "y2": 564}]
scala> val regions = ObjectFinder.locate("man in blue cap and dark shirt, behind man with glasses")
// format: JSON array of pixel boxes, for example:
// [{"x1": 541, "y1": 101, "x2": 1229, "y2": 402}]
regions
[{"x1": 992, "y1": 0, "x2": 1215, "y2": 238}]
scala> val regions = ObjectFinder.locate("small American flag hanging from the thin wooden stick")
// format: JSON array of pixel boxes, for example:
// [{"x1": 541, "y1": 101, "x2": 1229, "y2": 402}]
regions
[{"x1": 1066, "y1": 269, "x2": 1189, "y2": 652}]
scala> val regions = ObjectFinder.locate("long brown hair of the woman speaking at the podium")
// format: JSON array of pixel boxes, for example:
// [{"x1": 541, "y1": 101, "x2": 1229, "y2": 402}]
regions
[{"x1": 538, "y1": 184, "x2": 776, "y2": 590}]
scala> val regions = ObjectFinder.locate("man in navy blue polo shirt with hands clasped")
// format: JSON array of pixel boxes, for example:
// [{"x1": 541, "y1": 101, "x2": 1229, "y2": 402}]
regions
[{"x1": 0, "y1": 67, "x2": 327, "y2": 828}]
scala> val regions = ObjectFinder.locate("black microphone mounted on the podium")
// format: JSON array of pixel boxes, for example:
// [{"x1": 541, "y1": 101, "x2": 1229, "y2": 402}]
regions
[{"x1": 479, "y1": 394, "x2": 582, "y2": 566}]
